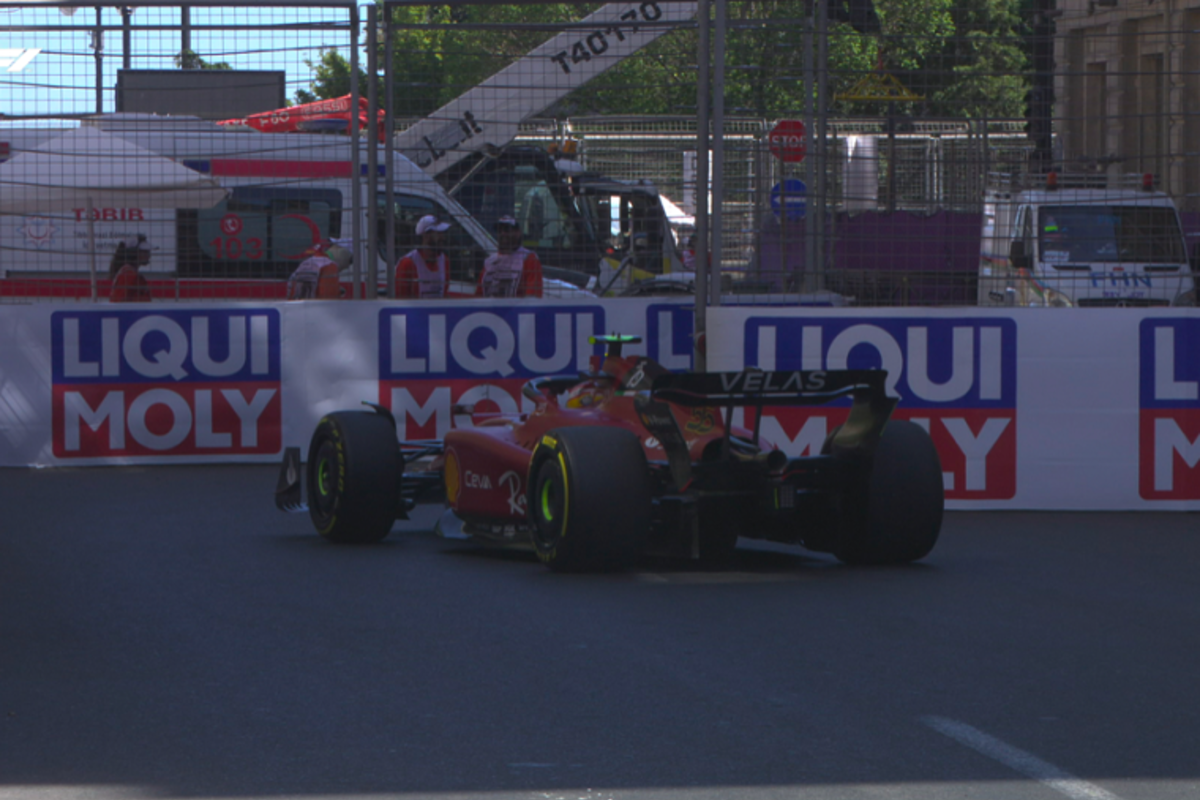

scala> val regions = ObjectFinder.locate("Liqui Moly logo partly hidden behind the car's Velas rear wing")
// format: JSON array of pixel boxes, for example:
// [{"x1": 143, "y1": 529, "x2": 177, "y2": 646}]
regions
[{"x1": 744, "y1": 317, "x2": 1016, "y2": 500}]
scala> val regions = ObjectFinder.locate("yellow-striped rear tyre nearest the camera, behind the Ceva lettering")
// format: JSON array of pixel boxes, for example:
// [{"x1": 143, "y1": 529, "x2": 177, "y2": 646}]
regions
[{"x1": 529, "y1": 427, "x2": 652, "y2": 572}]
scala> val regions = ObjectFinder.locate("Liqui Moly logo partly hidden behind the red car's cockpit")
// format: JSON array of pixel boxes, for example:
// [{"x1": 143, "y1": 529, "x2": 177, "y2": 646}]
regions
[{"x1": 379, "y1": 306, "x2": 605, "y2": 439}]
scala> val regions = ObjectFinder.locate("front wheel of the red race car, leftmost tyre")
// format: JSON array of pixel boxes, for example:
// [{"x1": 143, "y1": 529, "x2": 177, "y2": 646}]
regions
[{"x1": 307, "y1": 411, "x2": 403, "y2": 543}]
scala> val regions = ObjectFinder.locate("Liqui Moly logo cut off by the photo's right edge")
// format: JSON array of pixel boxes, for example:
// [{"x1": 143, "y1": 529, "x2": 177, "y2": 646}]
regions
[{"x1": 1138, "y1": 318, "x2": 1200, "y2": 500}]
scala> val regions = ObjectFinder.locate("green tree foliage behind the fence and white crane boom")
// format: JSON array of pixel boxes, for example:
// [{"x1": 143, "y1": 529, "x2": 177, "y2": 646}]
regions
[{"x1": 296, "y1": 0, "x2": 1028, "y2": 118}]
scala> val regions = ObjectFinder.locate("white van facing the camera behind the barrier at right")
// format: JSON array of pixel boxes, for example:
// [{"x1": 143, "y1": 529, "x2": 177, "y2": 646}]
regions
[{"x1": 979, "y1": 173, "x2": 1196, "y2": 307}]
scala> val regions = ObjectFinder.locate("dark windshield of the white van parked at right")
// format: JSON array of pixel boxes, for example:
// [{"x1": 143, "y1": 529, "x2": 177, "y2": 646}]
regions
[{"x1": 1038, "y1": 205, "x2": 1186, "y2": 264}]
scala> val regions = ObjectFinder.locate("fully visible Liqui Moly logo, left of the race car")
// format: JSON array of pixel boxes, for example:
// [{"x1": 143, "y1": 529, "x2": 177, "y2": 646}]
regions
[{"x1": 50, "y1": 308, "x2": 281, "y2": 458}]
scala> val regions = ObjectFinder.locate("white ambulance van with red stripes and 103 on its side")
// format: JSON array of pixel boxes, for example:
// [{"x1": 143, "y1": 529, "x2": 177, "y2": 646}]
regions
[{"x1": 0, "y1": 114, "x2": 496, "y2": 296}]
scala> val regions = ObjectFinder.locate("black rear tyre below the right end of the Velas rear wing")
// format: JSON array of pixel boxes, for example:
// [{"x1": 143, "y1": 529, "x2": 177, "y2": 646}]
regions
[{"x1": 834, "y1": 420, "x2": 946, "y2": 564}]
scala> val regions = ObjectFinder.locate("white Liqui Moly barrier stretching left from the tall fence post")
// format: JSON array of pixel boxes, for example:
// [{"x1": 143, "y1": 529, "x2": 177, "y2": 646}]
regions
[{"x1": 0, "y1": 299, "x2": 692, "y2": 467}]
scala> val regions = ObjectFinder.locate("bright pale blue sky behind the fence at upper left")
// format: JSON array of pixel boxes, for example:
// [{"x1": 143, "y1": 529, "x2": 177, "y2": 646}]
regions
[{"x1": 0, "y1": 6, "x2": 349, "y2": 126}]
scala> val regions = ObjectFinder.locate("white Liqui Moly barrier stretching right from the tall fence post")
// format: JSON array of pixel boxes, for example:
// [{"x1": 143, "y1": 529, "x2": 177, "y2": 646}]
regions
[{"x1": 708, "y1": 308, "x2": 1200, "y2": 510}]
